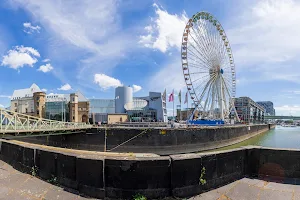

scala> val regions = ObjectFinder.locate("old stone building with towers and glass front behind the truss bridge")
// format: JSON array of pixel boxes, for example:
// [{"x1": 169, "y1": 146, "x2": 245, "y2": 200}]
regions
[{"x1": 10, "y1": 84, "x2": 90, "y2": 122}]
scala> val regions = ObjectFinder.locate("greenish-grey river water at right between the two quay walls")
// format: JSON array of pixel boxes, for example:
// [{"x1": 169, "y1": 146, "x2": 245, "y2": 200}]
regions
[{"x1": 217, "y1": 125, "x2": 300, "y2": 150}]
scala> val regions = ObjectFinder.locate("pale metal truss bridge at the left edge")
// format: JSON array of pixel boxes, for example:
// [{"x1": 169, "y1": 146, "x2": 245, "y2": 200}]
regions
[{"x1": 0, "y1": 108, "x2": 92, "y2": 134}]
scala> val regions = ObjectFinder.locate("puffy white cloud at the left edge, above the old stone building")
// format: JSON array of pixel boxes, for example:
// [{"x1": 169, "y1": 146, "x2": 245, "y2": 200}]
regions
[{"x1": 1, "y1": 46, "x2": 40, "y2": 69}]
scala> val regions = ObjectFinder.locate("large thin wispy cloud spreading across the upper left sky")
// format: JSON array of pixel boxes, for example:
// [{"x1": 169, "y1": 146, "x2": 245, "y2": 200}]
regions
[{"x1": 9, "y1": 0, "x2": 139, "y2": 87}]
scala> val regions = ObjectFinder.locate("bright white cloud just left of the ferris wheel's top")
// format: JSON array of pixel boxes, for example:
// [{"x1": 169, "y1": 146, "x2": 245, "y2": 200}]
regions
[{"x1": 139, "y1": 3, "x2": 188, "y2": 52}]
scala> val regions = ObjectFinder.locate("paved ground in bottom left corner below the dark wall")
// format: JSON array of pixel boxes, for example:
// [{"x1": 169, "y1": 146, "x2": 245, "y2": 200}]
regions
[{"x1": 0, "y1": 160, "x2": 95, "y2": 200}]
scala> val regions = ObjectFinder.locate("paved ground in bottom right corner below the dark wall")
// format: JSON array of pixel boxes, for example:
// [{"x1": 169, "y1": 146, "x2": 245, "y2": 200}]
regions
[{"x1": 189, "y1": 178, "x2": 300, "y2": 200}]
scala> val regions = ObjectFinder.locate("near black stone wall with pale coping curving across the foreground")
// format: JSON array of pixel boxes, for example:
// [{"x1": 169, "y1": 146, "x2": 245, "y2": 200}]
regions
[{"x1": 0, "y1": 140, "x2": 300, "y2": 199}]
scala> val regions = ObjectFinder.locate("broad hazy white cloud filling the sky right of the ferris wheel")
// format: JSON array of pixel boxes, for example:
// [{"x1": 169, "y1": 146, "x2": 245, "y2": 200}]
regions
[{"x1": 225, "y1": 0, "x2": 300, "y2": 83}]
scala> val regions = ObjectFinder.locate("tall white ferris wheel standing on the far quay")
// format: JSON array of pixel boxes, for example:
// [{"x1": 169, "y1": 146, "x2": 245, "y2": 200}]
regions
[{"x1": 181, "y1": 12, "x2": 236, "y2": 120}]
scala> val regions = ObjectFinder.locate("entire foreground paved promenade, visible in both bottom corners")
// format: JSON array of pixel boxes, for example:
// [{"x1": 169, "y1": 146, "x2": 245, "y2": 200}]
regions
[{"x1": 0, "y1": 160, "x2": 300, "y2": 200}]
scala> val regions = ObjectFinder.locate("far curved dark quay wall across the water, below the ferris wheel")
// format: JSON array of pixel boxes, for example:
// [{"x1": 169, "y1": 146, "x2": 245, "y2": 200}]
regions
[{"x1": 15, "y1": 124, "x2": 272, "y2": 155}]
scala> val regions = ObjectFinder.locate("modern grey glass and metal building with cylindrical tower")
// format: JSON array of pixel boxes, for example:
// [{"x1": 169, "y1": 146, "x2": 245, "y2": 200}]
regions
[{"x1": 90, "y1": 86, "x2": 167, "y2": 124}]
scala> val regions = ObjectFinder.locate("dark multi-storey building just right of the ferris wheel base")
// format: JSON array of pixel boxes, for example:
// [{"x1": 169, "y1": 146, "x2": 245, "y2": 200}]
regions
[{"x1": 234, "y1": 97, "x2": 265, "y2": 124}]
